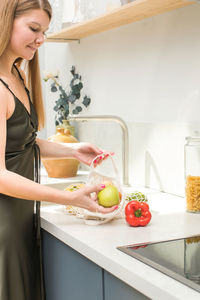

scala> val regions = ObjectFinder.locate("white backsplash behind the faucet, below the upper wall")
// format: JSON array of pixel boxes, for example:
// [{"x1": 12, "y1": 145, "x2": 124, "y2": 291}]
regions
[{"x1": 74, "y1": 121, "x2": 200, "y2": 196}]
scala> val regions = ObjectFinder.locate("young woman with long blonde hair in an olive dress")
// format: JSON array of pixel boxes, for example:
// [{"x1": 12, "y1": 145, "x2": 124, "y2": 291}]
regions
[{"x1": 0, "y1": 0, "x2": 115, "y2": 300}]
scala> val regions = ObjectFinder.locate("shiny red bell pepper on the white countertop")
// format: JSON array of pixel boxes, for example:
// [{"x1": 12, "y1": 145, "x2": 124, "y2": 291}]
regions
[{"x1": 125, "y1": 200, "x2": 151, "y2": 226}]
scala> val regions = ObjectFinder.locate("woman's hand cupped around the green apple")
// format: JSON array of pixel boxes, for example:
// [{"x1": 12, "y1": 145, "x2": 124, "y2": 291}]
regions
[{"x1": 69, "y1": 185, "x2": 118, "y2": 214}]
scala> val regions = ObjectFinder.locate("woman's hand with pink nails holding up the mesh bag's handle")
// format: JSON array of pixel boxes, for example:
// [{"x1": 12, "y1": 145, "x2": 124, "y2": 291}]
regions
[{"x1": 74, "y1": 143, "x2": 114, "y2": 166}]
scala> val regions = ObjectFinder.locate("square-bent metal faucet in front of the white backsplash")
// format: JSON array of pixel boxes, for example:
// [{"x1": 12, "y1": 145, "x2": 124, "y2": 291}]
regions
[{"x1": 68, "y1": 115, "x2": 130, "y2": 186}]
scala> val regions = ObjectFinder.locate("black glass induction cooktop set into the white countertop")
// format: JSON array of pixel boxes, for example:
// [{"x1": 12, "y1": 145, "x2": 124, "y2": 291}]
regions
[{"x1": 117, "y1": 235, "x2": 200, "y2": 292}]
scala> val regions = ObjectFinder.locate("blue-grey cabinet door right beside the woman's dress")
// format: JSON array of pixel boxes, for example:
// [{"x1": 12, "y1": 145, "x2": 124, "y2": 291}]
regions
[{"x1": 42, "y1": 230, "x2": 103, "y2": 300}]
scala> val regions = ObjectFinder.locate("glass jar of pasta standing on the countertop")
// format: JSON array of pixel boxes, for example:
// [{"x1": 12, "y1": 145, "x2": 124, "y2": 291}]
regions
[{"x1": 185, "y1": 137, "x2": 200, "y2": 213}]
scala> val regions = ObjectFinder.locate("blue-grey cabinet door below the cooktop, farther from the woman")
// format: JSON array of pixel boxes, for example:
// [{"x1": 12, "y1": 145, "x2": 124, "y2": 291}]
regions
[{"x1": 103, "y1": 271, "x2": 150, "y2": 300}]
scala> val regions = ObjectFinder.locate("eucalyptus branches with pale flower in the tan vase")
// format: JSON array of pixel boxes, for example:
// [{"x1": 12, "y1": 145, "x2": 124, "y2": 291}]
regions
[{"x1": 44, "y1": 66, "x2": 91, "y2": 126}]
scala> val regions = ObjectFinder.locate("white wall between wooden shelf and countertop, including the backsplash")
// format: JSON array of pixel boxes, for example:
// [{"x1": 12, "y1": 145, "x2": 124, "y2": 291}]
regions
[{"x1": 39, "y1": 4, "x2": 200, "y2": 195}]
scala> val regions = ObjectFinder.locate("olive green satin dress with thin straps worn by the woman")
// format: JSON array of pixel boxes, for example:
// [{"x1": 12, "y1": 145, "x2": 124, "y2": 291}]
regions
[{"x1": 0, "y1": 67, "x2": 45, "y2": 300}]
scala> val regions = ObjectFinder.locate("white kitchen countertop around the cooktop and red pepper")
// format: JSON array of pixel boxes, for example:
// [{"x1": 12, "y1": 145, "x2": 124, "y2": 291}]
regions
[{"x1": 41, "y1": 173, "x2": 200, "y2": 300}]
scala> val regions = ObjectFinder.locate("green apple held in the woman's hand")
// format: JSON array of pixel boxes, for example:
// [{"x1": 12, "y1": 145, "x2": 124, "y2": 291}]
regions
[{"x1": 98, "y1": 185, "x2": 120, "y2": 207}]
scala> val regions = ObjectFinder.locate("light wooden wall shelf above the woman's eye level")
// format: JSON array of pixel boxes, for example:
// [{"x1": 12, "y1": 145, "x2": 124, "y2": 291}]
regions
[{"x1": 46, "y1": 0, "x2": 196, "y2": 42}]
